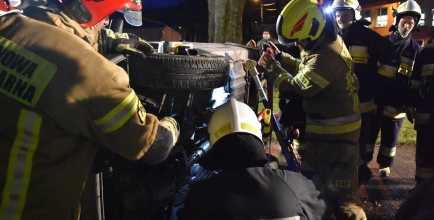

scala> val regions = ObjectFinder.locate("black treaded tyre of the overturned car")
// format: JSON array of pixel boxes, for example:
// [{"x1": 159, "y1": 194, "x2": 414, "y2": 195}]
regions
[{"x1": 128, "y1": 52, "x2": 230, "y2": 90}]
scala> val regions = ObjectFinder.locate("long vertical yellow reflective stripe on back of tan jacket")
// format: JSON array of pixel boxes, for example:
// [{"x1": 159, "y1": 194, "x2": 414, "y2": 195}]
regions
[{"x1": 0, "y1": 109, "x2": 42, "y2": 220}]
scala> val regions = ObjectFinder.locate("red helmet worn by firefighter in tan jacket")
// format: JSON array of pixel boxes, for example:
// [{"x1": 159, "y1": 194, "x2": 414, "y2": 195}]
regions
[{"x1": 59, "y1": 0, "x2": 142, "y2": 27}]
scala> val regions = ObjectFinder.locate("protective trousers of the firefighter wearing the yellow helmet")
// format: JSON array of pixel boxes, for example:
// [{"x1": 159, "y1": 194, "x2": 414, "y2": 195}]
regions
[{"x1": 301, "y1": 140, "x2": 366, "y2": 220}]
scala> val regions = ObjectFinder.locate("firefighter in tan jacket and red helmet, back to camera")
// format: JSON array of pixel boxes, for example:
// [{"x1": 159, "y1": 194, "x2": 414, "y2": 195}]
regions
[{"x1": 0, "y1": 0, "x2": 179, "y2": 219}]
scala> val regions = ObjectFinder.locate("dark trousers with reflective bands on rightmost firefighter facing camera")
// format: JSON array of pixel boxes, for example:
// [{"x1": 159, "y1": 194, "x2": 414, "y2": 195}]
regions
[{"x1": 366, "y1": 111, "x2": 404, "y2": 167}]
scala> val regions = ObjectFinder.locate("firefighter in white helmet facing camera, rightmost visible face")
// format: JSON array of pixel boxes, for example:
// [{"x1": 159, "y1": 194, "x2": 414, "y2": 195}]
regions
[{"x1": 366, "y1": 0, "x2": 421, "y2": 178}]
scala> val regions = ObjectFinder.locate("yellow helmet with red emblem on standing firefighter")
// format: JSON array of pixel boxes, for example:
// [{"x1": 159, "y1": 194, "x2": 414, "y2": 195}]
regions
[{"x1": 276, "y1": 0, "x2": 326, "y2": 43}]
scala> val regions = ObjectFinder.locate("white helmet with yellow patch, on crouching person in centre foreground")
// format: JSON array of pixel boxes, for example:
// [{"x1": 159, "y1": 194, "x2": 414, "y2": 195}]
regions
[{"x1": 208, "y1": 98, "x2": 262, "y2": 146}]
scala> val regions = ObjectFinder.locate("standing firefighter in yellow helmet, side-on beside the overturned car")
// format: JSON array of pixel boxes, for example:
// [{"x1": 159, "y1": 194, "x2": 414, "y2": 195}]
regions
[{"x1": 259, "y1": 0, "x2": 366, "y2": 219}]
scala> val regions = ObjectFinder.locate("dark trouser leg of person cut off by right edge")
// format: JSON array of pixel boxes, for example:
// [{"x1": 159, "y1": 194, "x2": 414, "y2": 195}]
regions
[{"x1": 415, "y1": 123, "x2": 434, "y2": 183}]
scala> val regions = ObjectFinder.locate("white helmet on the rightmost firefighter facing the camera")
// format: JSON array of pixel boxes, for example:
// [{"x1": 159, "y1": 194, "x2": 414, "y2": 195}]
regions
[{"x1": 390, "y1": 0, "x2": 422, "y2": 31}]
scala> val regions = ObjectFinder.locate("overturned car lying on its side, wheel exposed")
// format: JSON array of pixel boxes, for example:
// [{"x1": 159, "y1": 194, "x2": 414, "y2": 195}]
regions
[{"x1": 81, "y1": 42, "x2": 259, "y2": 219}]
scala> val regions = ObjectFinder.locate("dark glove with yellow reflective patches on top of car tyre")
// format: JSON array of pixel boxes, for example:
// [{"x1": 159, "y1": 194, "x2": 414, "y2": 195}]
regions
[{"x1": 101, "y1": 29, "x2": 154, "y2": 58}]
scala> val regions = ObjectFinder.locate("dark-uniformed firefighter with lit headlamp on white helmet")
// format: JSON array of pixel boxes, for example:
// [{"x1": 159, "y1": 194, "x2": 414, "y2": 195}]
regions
[{"x1": 331, "y1": 0, "x2": 400, "y2": 185}]
